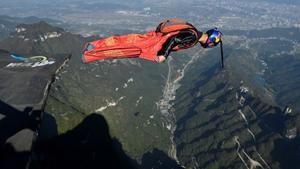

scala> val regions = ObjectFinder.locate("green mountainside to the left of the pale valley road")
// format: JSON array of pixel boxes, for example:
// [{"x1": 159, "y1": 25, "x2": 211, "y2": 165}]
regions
[{"x1": 0, "y1": 22, "x2": 190, "y2": 165}]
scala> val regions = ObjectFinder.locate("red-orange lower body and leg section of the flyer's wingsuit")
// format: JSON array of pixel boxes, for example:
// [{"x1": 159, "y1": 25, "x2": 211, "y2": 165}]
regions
[{"x1": 83, "y1": 31, "x2": 179, "y2": 63}]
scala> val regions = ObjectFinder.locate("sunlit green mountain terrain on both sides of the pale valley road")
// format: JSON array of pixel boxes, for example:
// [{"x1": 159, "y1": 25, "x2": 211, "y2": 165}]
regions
[{"x1": 0, "y1": 22, "x2": 300, "y2": 168}]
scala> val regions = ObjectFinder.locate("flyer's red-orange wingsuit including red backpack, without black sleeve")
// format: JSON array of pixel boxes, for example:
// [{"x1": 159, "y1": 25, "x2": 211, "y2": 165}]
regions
[{"x1": 83, "y1": 18, "x2": 199, "y2": 63}]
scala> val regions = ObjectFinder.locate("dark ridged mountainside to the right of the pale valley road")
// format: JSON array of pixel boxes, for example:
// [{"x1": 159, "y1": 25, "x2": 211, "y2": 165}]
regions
[{"x1": 172, "y1": 30, "x2": 300, "y2": 168}]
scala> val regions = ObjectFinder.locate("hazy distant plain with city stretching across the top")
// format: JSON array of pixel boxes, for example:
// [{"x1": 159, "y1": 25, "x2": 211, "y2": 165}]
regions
[{"x1": 0, "y1": 0, "x2": 300, "y2": 29}]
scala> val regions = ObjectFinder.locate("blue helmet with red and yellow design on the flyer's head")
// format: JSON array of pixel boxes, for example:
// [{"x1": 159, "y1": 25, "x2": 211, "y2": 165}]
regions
[{"x1": 201, "y1": 28, "x2": 222, "y2": 48}]
